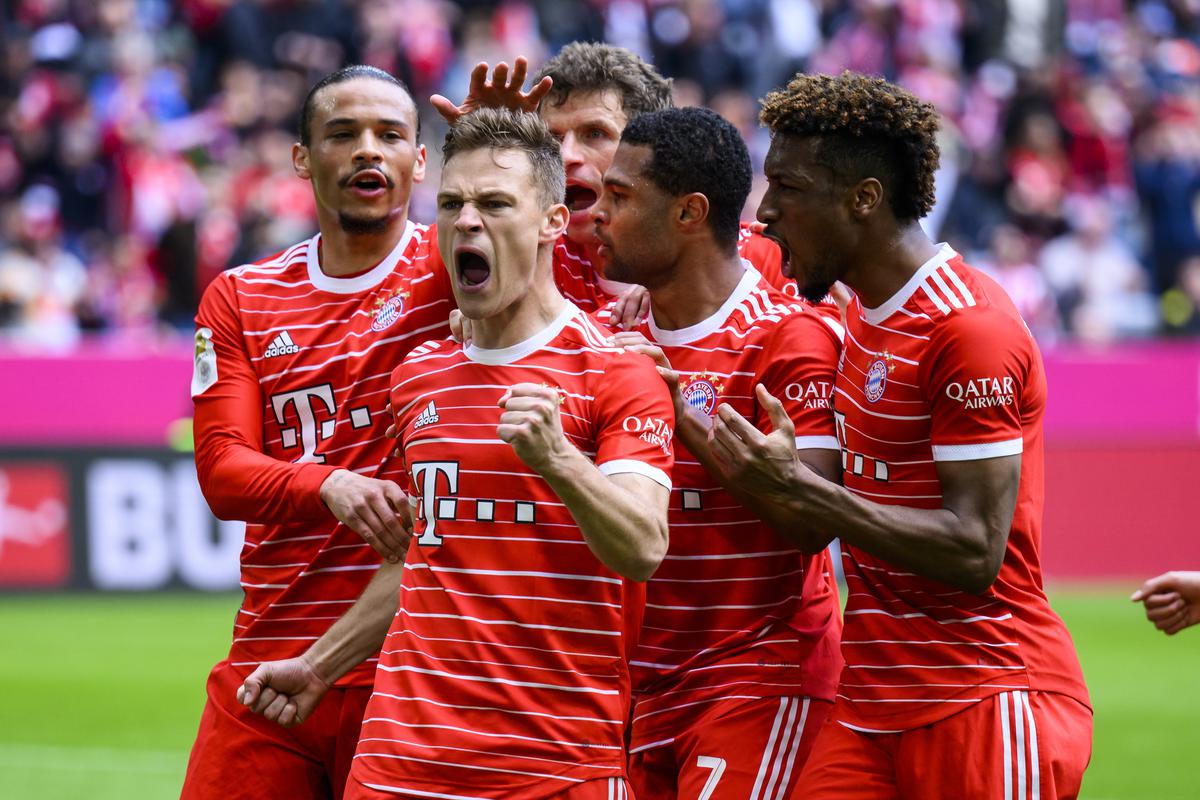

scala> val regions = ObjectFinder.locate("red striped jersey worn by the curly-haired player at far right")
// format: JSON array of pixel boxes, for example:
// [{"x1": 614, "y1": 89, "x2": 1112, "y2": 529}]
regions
[{"x1": 834, "y1": 245, "x2": 1087, "y2": 730}]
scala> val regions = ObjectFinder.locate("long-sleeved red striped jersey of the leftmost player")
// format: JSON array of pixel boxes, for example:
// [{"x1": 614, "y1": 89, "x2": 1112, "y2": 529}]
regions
[{"x1": 192, "y1": 222, "x2": 454, "y2": 686}]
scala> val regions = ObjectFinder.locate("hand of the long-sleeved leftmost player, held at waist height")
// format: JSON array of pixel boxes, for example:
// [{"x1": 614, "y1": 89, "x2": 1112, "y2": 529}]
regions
[{"x1": 320, "y1": 469, "x2": 413, "y2": 563}]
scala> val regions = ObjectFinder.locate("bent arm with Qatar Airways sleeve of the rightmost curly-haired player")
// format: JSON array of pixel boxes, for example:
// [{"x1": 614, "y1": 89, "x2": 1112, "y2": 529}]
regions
[{"x1": 714, "y1": 308, "x2": 1044, "y2": 594}]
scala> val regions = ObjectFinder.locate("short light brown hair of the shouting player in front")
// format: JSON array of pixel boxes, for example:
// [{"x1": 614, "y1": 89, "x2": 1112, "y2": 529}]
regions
[{"x1": 442, "y1": 108, "x2": 566, "y2": 207}]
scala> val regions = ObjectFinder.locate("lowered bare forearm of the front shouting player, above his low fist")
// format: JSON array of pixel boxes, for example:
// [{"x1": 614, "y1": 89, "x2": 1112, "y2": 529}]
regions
[{"x1": 302, "y1": 561, "x2": 404, "y2": 684}]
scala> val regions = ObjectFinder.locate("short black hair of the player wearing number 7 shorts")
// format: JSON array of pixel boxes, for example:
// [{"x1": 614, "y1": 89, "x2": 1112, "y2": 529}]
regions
[{"x1": 620, "y1": 108, "x2": 751, "y2": 251}]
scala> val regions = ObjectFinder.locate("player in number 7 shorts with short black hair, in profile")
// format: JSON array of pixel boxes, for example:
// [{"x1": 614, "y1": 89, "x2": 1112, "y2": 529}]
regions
[{"x1": 594, "y1": 108, "x2": 841, "y2": 798}]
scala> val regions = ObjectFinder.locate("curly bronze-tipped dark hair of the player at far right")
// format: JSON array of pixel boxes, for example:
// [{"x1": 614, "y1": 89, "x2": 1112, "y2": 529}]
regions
[{"x1": 758, "y1": 71, "x2": 938, "y2": 221}]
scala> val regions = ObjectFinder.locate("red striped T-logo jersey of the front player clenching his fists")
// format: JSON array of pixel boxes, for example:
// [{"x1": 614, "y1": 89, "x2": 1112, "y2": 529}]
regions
[{"x1": 353, "y1": 303, "x2": 674, "y2": 799}]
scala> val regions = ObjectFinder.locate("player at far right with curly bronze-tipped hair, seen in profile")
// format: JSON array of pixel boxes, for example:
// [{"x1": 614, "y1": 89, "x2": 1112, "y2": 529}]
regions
[{"x1": 713, "y1": 73, "x2": 1092, "y2": 799}]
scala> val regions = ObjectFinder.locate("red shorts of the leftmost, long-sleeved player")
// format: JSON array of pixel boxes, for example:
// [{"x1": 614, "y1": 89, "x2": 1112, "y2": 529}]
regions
[{"x1": 181, "y1": 661, "x2": 371, "y2": 800}]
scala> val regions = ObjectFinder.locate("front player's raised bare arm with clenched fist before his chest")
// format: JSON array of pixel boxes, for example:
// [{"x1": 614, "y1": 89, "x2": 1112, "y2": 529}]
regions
[{"x1": 497, "y1": 384, "x2": 670, "y2": 581}]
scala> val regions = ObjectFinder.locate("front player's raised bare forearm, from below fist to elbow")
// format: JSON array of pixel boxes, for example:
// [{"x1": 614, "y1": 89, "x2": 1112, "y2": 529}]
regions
[{"x1": 542, "y1": 447, "x2": 667, "y2": 581}]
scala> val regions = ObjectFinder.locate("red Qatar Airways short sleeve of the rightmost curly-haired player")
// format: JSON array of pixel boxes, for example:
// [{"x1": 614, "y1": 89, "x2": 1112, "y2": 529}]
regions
[{"x1": 923, "y1": 306, "x2": 1036, "y2": 461}]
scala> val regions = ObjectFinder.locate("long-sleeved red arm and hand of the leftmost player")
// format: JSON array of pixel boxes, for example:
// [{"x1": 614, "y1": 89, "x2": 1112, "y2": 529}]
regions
[{"x1": 192, "y1": 278, "x2": 408, "y2": 559}]
